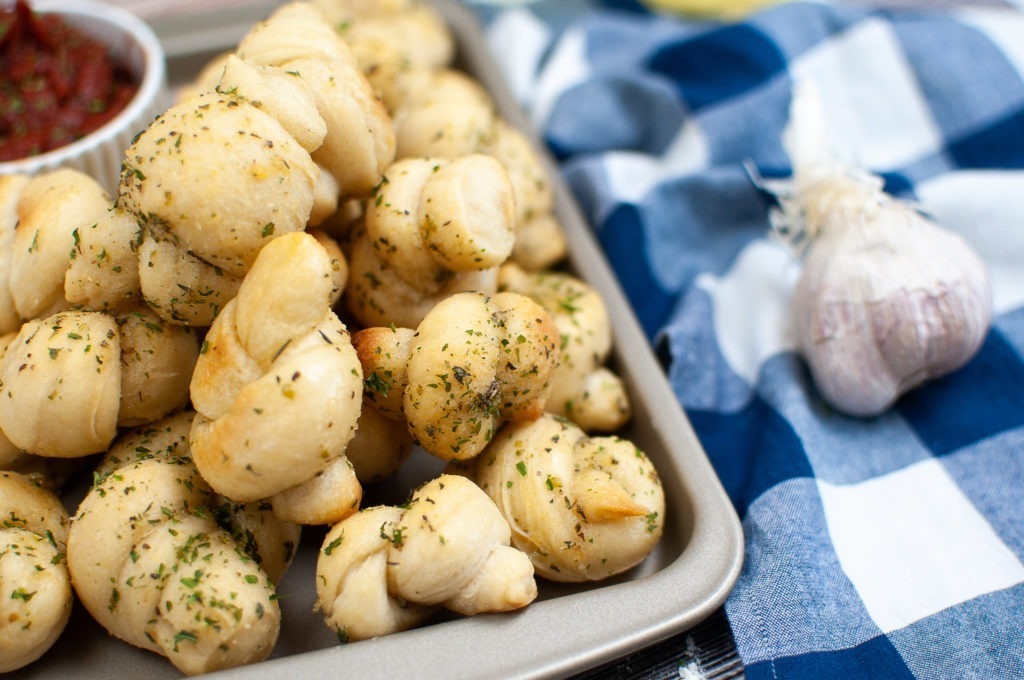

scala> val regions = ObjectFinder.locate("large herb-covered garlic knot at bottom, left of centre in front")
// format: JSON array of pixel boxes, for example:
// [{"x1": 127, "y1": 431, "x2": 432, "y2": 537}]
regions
[{"x1": 68, "y1": 415, "x2": 286, "y2": 675}]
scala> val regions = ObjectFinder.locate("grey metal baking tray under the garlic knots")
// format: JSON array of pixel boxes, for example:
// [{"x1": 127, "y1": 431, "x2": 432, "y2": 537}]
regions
[{"x1": 17, "y1": 0, "x2": 743, "y2": 680}]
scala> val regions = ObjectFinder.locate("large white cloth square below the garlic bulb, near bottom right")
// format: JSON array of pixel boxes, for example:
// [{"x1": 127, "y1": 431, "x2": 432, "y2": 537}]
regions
[{"x1": 818, "y1": 459, "x2": 1024, "y2": 633}]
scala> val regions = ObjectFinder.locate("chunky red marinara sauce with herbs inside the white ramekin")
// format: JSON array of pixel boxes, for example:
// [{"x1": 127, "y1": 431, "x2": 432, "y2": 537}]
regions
[{"x1": 0, "y1": 0, "x2": 138, "y2": 161}]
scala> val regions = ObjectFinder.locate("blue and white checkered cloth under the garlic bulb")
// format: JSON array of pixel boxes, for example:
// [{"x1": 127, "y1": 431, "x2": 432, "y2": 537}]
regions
[{"x1": 468, "y1": 0, "x2": 1024, "y2": 679}]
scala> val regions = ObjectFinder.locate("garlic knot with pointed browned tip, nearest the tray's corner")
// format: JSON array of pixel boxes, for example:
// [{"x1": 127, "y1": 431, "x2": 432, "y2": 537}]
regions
[{"x1": 453, "y1": 414, "x2": 665, "y2": 582}]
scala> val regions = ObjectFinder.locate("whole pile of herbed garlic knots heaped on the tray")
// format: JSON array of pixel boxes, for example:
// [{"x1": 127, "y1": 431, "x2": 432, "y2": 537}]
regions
[{"x1": 0, "y1": 0, "x2": 665, "y2": 675}]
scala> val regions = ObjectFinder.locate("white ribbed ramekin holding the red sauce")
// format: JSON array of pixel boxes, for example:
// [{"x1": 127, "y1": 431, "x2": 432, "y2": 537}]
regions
[{"x1": 0, "y1": 0, "x2": 169, "y2": 196}]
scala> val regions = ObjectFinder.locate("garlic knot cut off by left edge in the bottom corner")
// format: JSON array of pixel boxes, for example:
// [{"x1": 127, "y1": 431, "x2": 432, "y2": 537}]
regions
[{"x1": 0, "y1": 472, "x2": 72, "y2": 673}]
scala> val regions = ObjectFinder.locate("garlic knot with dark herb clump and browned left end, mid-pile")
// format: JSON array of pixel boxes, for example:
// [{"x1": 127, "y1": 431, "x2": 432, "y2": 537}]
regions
[{"x1": 353, "y1": 293, "x2": 558, "y2": 461}]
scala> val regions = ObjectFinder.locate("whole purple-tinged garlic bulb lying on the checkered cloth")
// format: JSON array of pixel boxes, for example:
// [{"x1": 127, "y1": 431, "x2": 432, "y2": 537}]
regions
[{"x1": 774, "y1": 82, "x2": 992, "y2": 416}]
